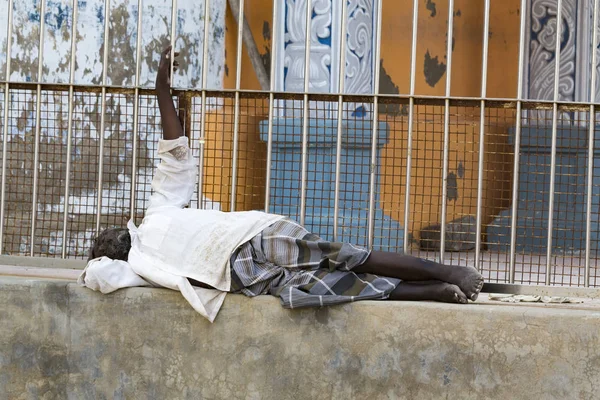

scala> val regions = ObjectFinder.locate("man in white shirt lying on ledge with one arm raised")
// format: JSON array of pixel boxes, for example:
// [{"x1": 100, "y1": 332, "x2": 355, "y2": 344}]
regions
[{"x1": 79, "y1": 47, "x2": 483, "y2": 322}]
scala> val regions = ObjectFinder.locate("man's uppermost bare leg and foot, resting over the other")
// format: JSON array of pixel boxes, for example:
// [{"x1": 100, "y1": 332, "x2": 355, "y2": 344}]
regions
[{"x1": 353, "y1": 251, "x2": 483, "y2": 300}]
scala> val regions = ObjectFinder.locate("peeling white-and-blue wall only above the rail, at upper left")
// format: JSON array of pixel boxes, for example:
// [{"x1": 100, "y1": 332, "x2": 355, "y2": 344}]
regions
[{"x1": 0, "y1": 0, "x2": 226, "y2": 89}]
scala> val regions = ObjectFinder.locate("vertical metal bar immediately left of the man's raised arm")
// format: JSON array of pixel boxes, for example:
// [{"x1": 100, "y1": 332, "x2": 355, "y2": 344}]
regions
[{"x1": 129, "y1": 0, "x2": 143, "y2": 221}]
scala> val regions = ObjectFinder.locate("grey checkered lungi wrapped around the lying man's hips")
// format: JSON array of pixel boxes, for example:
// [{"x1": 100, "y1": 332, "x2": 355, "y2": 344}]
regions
[{"x1": 231, "y1": 219, "x2": 400, "y2": 308}]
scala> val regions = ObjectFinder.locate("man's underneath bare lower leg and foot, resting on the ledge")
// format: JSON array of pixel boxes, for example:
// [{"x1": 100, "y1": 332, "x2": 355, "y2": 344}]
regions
[{"x1": 390, "y1": 281, "x2": 468, "y2": 304}]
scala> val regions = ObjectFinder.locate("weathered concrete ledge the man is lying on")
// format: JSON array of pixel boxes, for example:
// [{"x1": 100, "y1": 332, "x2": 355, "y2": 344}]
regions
[{"x1": 0, "y1": 277, "x2": 600, "y2": 400}]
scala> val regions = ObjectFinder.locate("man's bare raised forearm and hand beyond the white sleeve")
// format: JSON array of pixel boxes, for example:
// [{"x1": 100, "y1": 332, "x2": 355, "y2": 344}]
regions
[{"x1": 156, "y1": 46, "x2": 183, "y2": 140}]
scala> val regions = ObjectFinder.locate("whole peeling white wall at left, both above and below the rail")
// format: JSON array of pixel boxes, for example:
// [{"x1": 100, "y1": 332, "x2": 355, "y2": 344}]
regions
[{"x1": 0, "y1": 0, "x2": 226, "y2": 256}]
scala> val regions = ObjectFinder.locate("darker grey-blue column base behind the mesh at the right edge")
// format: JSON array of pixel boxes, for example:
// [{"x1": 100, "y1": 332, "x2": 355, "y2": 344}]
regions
[{"x1": 487, "y1": 127, "x2": 600, "y2": 254}]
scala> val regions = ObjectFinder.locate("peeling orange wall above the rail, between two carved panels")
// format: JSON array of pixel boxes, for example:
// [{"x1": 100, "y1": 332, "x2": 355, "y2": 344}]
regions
[{"x1": 381, "y1": 0, "x2": 520, "y2": 97}]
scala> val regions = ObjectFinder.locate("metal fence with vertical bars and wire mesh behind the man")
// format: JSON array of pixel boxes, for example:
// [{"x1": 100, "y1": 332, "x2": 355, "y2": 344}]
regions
[{"x1": 0, "y1": 0, "x2": 600, "y2": 287}]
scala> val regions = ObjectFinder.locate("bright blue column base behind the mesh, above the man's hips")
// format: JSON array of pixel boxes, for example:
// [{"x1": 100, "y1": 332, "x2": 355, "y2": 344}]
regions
[{"x1": 260, "y1": 118, "x2": 404, "y2": 251}]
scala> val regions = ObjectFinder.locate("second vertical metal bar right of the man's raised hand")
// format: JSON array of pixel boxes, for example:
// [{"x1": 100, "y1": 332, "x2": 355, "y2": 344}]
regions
[{"x1": 230, "y1": 0, "x2": 244, "y2": 211}]
